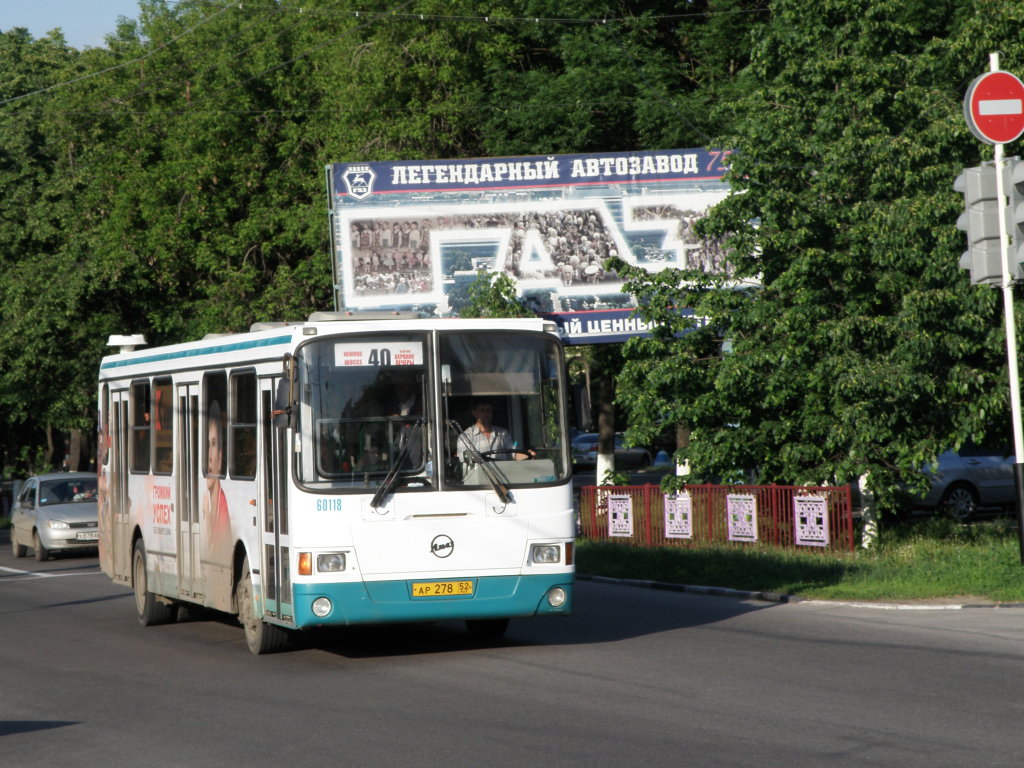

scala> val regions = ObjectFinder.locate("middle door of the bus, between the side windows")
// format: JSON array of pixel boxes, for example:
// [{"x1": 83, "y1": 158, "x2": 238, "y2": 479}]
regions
[{"x1": 175, "y1": 384, "x2": 205, "y2": 602}]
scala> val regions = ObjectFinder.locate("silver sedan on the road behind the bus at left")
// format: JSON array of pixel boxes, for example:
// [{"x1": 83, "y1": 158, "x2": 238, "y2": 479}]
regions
[{"x1": 10, "y1": 472, "x2": 99, "y2": 560}]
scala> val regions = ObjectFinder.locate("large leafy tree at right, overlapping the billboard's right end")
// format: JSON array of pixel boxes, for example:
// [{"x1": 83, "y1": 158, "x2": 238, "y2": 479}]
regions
[{"x1": 621, "y1": 0, "x2": 1024, "y2": 505}]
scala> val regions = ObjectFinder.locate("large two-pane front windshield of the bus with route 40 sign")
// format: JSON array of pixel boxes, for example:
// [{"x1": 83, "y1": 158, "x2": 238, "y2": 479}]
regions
[{"x1": 297, "y1": 331, "x2": 567, "y2": 492}]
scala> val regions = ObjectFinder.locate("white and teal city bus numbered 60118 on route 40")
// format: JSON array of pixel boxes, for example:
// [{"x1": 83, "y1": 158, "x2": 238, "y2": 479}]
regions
[{"x1": 97, "y1": 312, "x2": 575, "y2": 654}]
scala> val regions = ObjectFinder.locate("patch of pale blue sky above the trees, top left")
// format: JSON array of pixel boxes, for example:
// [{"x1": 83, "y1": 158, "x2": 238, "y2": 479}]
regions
[{"x1": 0, "y1": 0, "x2": 138, "y2": 50}]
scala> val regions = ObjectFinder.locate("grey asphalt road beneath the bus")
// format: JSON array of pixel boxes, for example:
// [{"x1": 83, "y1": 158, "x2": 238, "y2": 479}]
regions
[{"x1": 0, "y1": 546, "x2": 1024, "y2": 768}]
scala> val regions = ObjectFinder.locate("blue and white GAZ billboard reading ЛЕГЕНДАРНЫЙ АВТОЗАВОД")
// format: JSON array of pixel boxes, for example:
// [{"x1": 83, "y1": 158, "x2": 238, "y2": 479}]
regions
[{"x1": 327, "y1": 150, "x2": 729, "y2": 343}]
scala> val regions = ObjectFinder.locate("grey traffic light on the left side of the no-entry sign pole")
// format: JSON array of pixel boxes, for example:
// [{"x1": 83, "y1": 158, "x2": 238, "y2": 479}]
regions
[{"x1": 953, "y1": 163, "x2": 1003, "y2": 286}]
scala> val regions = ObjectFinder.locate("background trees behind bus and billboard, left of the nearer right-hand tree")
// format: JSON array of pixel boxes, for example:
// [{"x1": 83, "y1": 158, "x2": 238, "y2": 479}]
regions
[{"x1": 0, "y1": 0, "x2": 767, "y2": 475}]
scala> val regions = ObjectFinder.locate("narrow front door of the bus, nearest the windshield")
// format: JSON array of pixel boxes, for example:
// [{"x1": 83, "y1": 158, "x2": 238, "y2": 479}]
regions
[{"x1": 259, "y1": 378, "x2": 295, "y2": 623}]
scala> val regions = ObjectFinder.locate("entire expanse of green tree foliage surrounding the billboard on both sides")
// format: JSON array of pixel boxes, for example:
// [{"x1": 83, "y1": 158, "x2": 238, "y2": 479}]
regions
[{"x1": 0, "y1": 0, "x2": 1024, "y2": 488}]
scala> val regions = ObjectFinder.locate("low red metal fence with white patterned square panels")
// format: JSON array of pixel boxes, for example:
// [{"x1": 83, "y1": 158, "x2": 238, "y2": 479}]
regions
[{"x1": 580, "y1": 484, "x2": 855, "y2": 552}]
